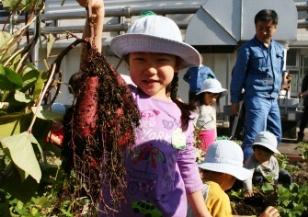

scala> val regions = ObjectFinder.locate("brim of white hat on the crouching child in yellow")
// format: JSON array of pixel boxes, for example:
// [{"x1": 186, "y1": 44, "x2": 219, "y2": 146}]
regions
[{"x1": 198, "y1": 163, "x2": 252, "y2": 181}]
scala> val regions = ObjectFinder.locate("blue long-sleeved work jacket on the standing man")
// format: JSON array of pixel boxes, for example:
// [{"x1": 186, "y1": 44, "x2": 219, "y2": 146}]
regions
[{"x1": 230, "y1": 37, "x2": 284, "y2": 103}]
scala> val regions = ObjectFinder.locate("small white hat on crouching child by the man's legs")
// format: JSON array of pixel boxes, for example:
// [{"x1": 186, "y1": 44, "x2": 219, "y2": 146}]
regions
[{"x1": 252, "y1": 131, "x2": 280, "y2": 154}]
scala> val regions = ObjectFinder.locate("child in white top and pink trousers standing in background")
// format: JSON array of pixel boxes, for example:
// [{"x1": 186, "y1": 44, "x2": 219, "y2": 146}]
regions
[{"x1": 196, "y1": 78, "x2": 227, "y2": 151}]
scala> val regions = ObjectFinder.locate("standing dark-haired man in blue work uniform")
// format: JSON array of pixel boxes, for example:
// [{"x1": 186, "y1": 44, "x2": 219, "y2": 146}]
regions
[{"x1": 230, "y1": 9, "x2": 284, "y2": 159}]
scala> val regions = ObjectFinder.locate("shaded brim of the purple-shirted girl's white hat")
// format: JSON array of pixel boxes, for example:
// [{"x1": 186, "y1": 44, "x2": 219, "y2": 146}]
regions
[{"x1": 110, "y1": 33, "x2": 202, "y2": 68}]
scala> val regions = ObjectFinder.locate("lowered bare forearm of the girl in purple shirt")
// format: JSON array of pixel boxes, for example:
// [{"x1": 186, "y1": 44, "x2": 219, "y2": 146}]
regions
[{"x1": 187, "y1": 191, "x2": 211, "y2": 217}]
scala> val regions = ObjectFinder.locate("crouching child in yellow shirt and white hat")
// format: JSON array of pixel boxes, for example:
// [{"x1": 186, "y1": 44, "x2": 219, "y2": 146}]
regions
[{"x1": 187, "y1": 140, "x2": 279, "y2": 217}]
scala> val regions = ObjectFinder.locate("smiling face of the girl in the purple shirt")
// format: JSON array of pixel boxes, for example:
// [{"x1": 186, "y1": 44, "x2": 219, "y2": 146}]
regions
[{"x1": 128, "y1": 52, "x2": 178, "y2": 100}]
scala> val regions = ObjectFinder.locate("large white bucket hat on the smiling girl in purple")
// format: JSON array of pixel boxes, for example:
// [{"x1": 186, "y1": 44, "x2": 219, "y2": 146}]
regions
[{"x1": 110, "y1": 15, "x2": 202, "y2": 68}]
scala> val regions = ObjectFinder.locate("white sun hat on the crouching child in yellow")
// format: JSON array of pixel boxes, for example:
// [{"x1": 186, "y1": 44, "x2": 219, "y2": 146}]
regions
[{"x1": 199, "y1": 140, "x2": 251, "y2": 180}]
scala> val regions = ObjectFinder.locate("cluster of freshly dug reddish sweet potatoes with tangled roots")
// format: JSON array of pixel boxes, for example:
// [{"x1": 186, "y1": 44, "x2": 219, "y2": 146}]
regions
[{"x1": 66, "y1": 49, "x2": 140, "y2": 216}]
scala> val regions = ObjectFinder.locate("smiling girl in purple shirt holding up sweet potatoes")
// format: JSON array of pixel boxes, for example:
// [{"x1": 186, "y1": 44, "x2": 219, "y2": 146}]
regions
[{"x1": 78, "y1": 0, "x2": 210, "y2": 217}]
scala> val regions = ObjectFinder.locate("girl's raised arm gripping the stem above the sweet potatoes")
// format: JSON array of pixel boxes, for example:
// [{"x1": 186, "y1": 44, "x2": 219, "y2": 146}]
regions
[{"x1": 76, "y1": 0, "x2": 105, "y2": 66}]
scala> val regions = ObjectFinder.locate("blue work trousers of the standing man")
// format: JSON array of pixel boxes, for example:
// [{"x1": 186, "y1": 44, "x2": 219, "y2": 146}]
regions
[{"x1": 242, "y1": 96, "x2": 281, "y2": 160}]
